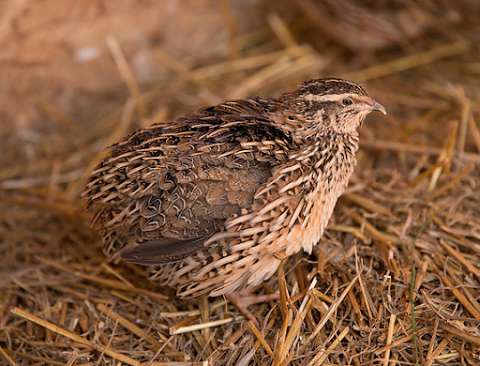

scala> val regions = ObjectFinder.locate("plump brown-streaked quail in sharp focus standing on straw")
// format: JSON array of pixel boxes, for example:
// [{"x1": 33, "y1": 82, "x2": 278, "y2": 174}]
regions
[{"x1": 84, "y1": 78, "x2": 386, "y2": 318}]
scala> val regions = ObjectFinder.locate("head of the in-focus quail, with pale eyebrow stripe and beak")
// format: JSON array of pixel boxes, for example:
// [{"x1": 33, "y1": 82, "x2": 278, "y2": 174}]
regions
[{"x1": 285, "y1": 78, "x2": 386, "y2": 133}]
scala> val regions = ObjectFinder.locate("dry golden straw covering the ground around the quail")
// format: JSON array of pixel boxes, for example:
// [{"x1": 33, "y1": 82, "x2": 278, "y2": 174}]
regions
[{"x1": 0, "y1": 2, "x2": 480, "y2": 366}]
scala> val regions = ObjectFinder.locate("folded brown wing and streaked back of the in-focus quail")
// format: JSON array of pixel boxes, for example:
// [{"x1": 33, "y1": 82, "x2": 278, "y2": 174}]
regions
[{"x1": 84, "y1": 99, "x2": 290, "y2": 258}]
